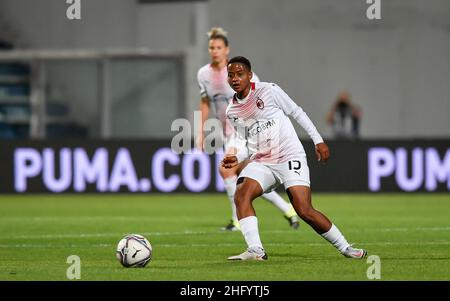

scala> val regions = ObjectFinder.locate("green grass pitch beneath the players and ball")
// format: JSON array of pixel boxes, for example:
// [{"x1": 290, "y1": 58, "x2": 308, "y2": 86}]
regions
[{"x1": 0, "y1": 193, "x2": 450, "y2": 281}]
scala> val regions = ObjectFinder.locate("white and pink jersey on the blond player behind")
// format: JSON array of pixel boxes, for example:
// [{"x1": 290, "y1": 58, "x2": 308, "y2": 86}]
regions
[{"x1": 197, "y1": 64, "x2": 259, "y2": 136}]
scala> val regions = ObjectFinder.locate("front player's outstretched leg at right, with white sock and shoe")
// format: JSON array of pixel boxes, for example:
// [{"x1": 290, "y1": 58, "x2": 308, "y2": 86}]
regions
[{"x1": 286, "y1": 185, "x2": 367, "y2": 258}]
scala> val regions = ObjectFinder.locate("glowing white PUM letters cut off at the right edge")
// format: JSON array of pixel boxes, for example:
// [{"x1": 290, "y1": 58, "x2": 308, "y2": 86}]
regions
[{"x1": 368, "y1": 147, "x2": 450, "y2": 191}]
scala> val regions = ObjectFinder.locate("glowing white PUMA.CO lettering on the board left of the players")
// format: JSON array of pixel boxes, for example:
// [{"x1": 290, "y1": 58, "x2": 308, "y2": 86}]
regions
[{"x1": 13, "y1": 147, "x2": 223, "y2": 192}]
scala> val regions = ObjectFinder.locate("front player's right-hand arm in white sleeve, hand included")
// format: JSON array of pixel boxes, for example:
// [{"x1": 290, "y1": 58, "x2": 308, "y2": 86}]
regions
[{"x1": 272, "y1": 84, "x2": 330, "y2": 162}]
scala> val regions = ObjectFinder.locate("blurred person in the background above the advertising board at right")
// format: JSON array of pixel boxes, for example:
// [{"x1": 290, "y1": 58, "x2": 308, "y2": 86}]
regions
[{"x1": 327, "y1": 91, "x2": 362, "y2": 139}]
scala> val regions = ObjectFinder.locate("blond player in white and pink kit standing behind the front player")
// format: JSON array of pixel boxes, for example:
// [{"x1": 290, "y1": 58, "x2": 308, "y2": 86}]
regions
[{"x1": 197, "y1": 27, "x2": 300, "y2": 231}]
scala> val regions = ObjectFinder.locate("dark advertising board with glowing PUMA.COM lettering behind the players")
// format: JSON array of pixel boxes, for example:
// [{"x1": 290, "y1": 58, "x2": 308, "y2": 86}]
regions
[{"x1": 0, "y1": 140, "x2": 450, "y2": 193}]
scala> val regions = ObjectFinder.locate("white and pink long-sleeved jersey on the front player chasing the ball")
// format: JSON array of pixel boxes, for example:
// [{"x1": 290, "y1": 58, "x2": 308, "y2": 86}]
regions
[{"x1": 226, "y1": 82, "x2": 323, "y2": 163}]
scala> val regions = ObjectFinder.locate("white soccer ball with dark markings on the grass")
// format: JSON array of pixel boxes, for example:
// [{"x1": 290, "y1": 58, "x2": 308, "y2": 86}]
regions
[{"x1": 116, "y1": 234, "x2": 153, "y2": 268}]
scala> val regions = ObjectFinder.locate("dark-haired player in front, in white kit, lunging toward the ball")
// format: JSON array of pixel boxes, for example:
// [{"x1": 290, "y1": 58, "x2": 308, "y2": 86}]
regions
[{"x1": 222, "y1": 57, "x2": 367, "y2": 260}]
